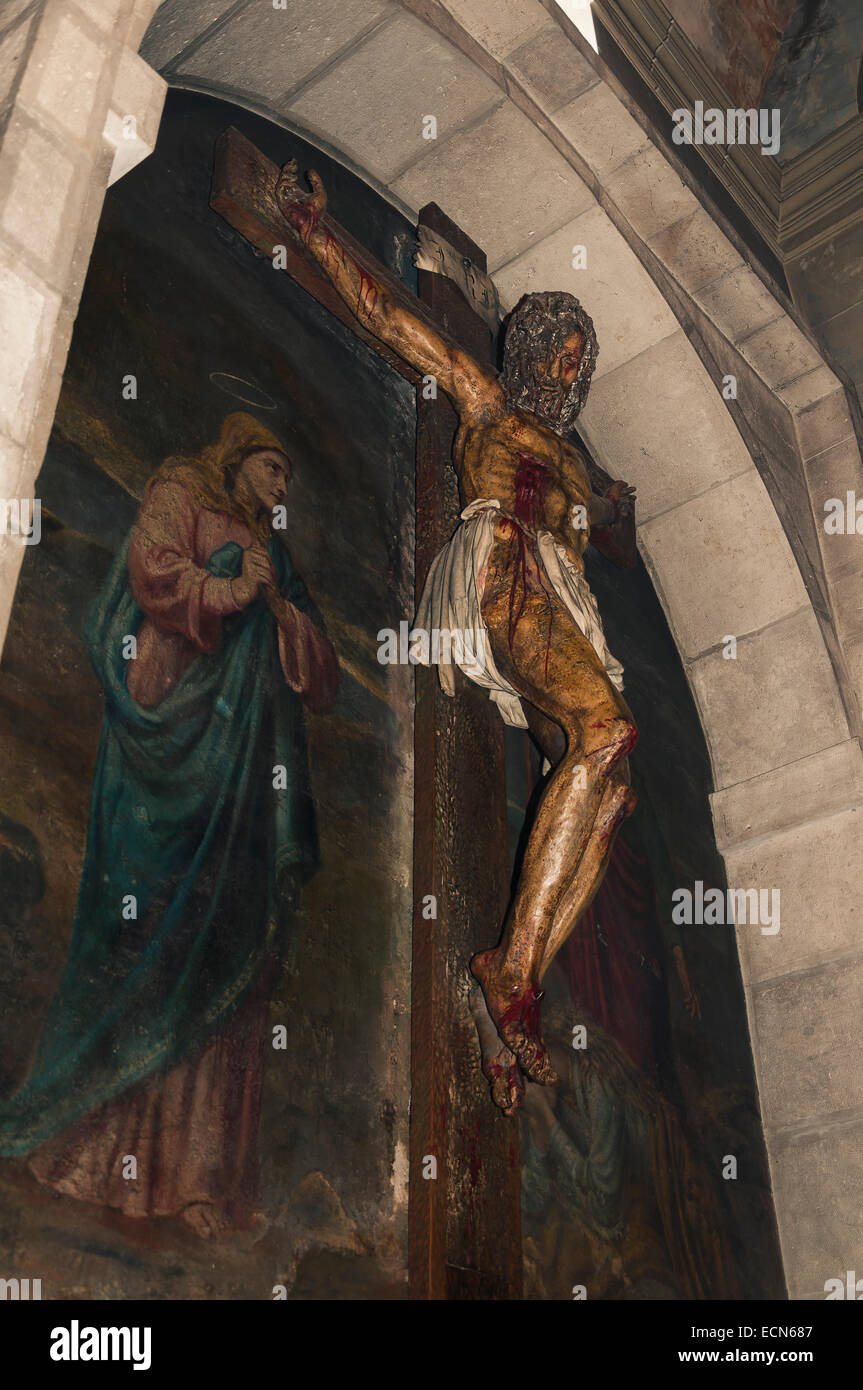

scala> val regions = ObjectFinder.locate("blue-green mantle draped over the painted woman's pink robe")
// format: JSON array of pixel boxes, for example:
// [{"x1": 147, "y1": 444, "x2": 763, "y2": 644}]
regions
[{"x1": 0, "y1": 416, "x2": 338, "y2": 1173}]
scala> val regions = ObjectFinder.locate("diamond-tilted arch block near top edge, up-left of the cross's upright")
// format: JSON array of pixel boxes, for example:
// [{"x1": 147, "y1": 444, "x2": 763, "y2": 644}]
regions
[{"x1": 288, "y1": 6, "x2": 502, "y2": 182}]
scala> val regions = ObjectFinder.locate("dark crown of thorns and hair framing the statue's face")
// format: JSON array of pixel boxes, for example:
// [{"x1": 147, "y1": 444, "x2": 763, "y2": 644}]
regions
[{"x1": 503, "y1": 291, "x2": 599, "y2": 410}]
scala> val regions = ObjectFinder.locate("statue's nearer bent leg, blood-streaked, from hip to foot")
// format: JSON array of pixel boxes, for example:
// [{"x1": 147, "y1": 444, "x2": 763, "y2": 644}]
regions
[{"x1": 471, "y1": 518, "x2": 636, "y2": 1083}]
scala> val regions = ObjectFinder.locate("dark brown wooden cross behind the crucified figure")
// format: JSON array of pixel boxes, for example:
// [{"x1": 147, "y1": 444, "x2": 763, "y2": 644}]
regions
[{"x1": 210, "y1": 129, "x2": 521, "y2": 1298}]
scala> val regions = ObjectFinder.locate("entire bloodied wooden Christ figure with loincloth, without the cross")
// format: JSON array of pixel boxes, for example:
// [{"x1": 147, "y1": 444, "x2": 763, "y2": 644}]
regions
[{"x1": 277, "y1": 161, "x2": 638, "y2": 1115}]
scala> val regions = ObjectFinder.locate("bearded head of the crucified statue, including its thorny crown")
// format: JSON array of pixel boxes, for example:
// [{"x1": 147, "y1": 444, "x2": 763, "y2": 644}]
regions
[{"x1": 502, "y1": 291, "x2": 599, "y2": 435}]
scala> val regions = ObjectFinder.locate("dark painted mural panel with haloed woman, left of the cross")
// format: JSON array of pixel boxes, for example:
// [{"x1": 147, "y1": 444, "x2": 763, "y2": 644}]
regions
[{"x1": 0, "y1": 93, "x2": 416, "y2": 1298}]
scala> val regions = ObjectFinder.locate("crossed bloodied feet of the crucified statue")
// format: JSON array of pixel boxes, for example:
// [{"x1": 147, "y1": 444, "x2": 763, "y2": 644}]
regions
[{"x1": 470, "y1": 948, "x2": 560, "y2": 1115}]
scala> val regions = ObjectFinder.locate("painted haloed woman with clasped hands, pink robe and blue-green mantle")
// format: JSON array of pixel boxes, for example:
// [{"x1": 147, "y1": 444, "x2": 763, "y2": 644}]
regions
[{"x1": 0, "y1": 413, "x2": 339, "y2": 1237}]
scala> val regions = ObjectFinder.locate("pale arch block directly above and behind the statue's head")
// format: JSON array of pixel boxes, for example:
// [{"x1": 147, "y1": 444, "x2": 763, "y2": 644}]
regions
[{"x1": 495, "y1": 206, "x2": 678, "y2": 381}]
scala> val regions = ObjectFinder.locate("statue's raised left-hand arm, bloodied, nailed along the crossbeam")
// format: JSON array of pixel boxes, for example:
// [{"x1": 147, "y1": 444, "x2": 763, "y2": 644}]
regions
[{"x1": 275, "y1": 160, "x2": 503, "y2": 418}]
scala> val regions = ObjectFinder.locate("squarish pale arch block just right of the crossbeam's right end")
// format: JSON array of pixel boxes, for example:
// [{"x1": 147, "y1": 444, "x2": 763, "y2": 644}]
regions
[{"x1": 639, "y1": 467, "x2": 807, "y2": 657}]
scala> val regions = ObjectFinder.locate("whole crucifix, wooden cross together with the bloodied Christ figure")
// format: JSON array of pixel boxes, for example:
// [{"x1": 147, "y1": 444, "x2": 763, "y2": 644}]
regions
[{"x1": 211, "y1": 131, "x2": 636, "y2": 1297}]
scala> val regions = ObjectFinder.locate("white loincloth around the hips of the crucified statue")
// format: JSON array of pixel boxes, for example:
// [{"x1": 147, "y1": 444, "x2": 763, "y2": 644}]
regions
[{"x1": 414, "y1": 498, "x2": 623, "y2": 728}]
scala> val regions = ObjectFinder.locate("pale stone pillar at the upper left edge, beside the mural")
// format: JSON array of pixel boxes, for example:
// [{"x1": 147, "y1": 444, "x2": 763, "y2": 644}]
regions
[{"x1": 0, "y1": 0, "x2": 165, "y2": 649}]
